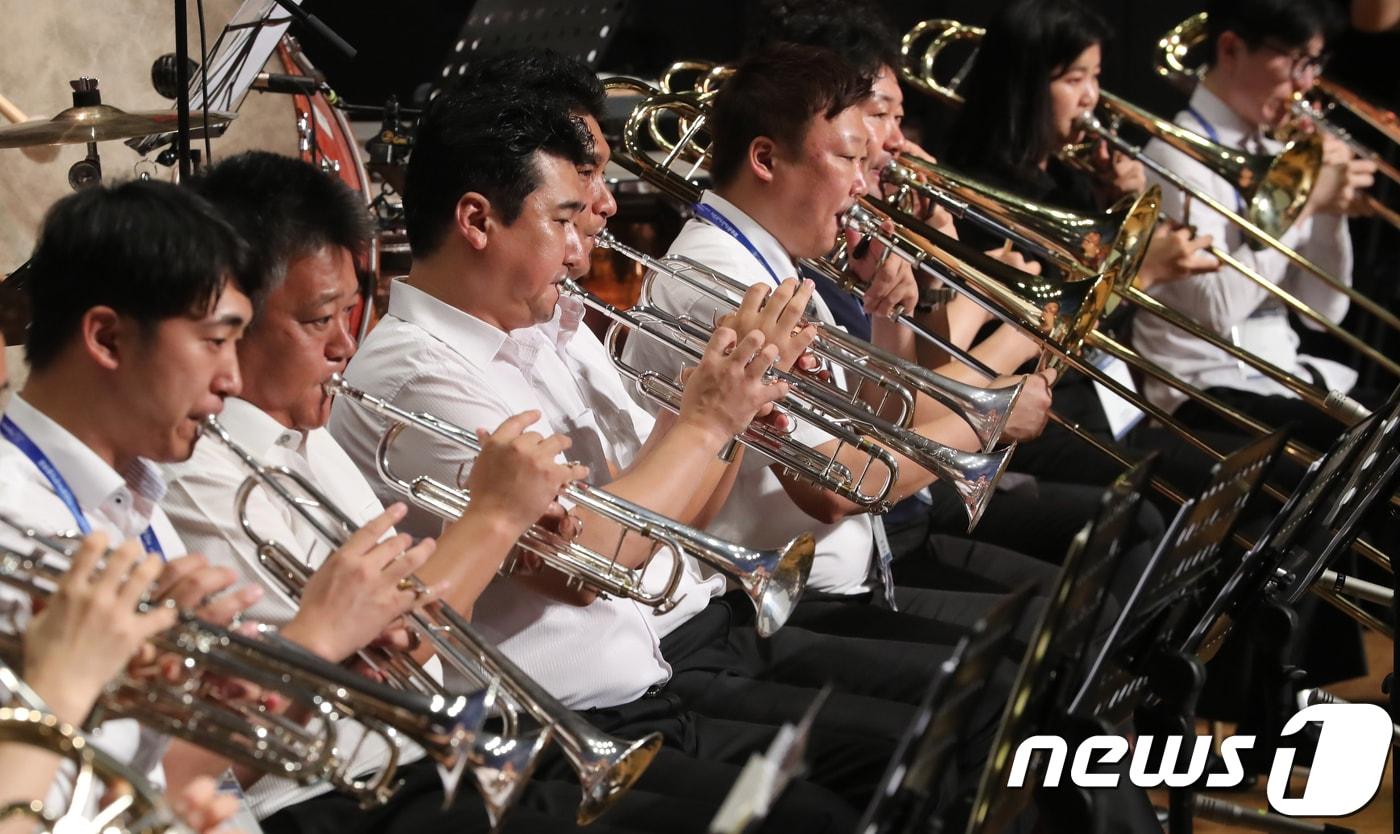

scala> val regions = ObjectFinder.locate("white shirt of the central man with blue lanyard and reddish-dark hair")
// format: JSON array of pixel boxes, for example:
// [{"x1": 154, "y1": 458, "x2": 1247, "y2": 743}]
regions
[{"x1": 623, "y1": 192, "x2": 875, "y2": 593}]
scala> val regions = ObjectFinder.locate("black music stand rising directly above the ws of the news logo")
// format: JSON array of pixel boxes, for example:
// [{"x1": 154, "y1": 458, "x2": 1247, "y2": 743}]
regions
[{"x1": 1067, "y1": 431, "x2": 1285, "y2": 834}]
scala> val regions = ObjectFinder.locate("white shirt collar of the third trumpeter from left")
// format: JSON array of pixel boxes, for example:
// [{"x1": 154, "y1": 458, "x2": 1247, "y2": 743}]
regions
[{"x1": 388, "y1": 280, "x2": 585, "y2": 367}]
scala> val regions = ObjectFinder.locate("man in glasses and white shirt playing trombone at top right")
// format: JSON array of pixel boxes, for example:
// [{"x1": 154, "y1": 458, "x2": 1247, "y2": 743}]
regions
[{"x1": 1133, "y1": 0, "x2": 1375, "y2": 449}]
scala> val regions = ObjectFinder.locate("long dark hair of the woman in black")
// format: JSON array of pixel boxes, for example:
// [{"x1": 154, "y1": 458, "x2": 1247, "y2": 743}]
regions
[{"x1": 944, "y1": 0, "x2": 1109, "y2": 179}]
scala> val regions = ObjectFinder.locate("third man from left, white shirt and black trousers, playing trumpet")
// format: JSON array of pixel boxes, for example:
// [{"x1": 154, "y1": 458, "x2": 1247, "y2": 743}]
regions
[{"x1": 330, "y1": 70, "x2": 1008, "y2": 822}]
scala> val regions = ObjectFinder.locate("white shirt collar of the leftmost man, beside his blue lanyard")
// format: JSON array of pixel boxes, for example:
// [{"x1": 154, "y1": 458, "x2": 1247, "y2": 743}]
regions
[{"x1": 6, "y1": 395, "x2": 165, "y2": 512}]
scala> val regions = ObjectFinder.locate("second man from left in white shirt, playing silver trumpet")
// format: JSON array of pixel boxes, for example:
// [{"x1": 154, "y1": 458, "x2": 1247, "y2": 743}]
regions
[{"x1": 179, "y1": 153, "x2": 856, "y2": 834}]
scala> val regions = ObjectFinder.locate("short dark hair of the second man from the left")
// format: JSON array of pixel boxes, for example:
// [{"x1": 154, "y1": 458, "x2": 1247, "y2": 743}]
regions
[{"x1": 192, "y1": 151, "x2": 370, "y2": 309}]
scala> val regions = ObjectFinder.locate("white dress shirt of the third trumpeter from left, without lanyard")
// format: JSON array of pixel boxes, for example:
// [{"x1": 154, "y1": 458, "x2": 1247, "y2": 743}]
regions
[{"x1": 330, "y1": 281, "x2": 724, "y2": 709}]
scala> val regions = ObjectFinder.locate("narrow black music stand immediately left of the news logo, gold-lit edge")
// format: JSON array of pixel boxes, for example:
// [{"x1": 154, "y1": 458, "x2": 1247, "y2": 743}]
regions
[{"x1": 948, "y1": 456, "x2": 1155, "y2": 834}]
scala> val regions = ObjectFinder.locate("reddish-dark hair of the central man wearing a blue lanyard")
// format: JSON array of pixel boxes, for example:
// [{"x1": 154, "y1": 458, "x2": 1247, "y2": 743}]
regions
[{"x1": 710, "y1": 43, "x2": 874, "y2": 185}]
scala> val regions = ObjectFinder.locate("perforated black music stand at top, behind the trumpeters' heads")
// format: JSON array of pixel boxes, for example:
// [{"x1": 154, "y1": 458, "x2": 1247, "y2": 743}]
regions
[{"x1": 431, "y1": 0, "x2": 627, "y2": 95}]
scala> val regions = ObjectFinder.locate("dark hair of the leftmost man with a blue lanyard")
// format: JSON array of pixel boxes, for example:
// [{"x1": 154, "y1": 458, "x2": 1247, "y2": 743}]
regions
[{"x1": 25, "y1": 181, "x2": 259, "y2": 371}]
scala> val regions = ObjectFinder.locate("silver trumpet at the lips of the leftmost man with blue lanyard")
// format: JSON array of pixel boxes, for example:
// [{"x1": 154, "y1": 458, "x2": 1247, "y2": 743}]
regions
[{"x1": 204, "y1": 417, "x2": 661, "y2": 828}]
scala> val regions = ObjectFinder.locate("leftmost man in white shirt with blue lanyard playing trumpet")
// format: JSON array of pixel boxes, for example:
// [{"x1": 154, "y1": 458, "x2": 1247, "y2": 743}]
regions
[{"x1": 0, "y1": 182, "x2": 273, "y2": 828}]
